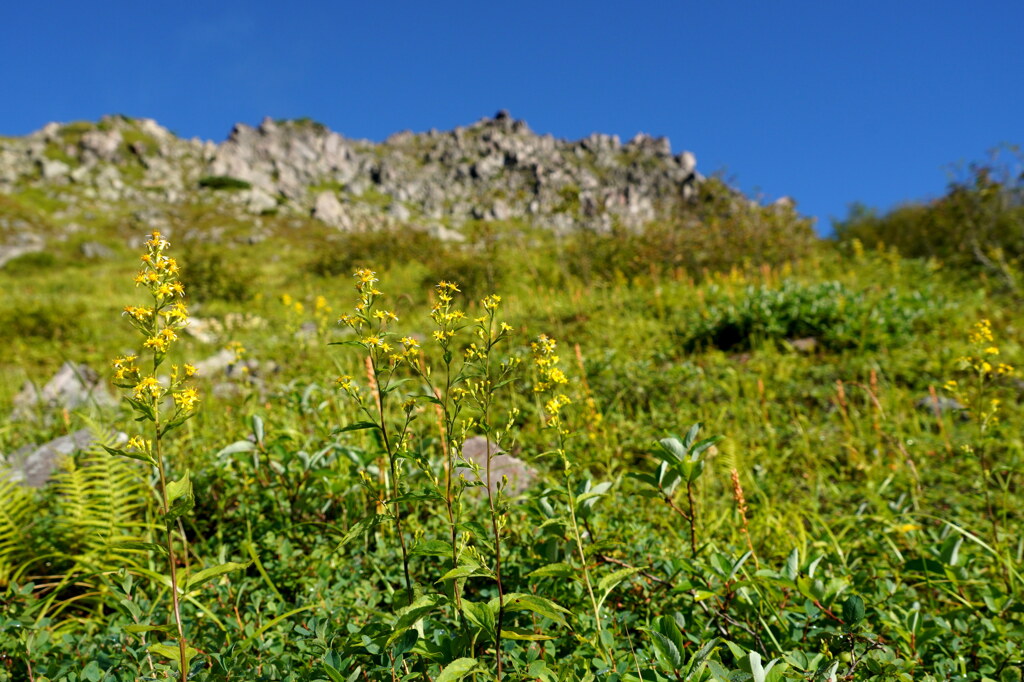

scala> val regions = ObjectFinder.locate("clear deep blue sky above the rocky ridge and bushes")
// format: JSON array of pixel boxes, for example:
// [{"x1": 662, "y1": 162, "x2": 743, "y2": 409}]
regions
[{"x1": 0, "y1": 0, "x2": 1024, "y2": 231}]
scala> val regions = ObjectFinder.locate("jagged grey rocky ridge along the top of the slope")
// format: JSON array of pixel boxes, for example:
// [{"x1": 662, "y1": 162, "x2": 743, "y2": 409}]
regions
[{"x1": 0, "y1": 112, "x2": 702, "y2": 260}]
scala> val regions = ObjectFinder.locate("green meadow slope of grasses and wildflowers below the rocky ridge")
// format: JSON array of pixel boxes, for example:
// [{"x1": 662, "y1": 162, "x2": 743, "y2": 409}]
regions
[{"x1": 0, "y1": 160, "x2": 1024, "y2": 682}]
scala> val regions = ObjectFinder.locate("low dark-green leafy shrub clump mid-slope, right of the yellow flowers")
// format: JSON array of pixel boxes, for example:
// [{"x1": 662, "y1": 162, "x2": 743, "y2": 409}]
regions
[{"x1": 679, "y1": 281, "x2": 935, "y2": 350}]
